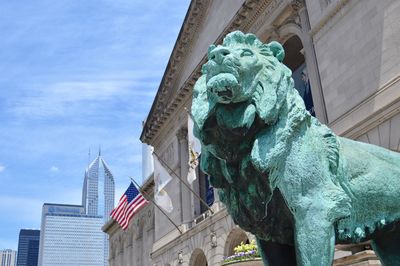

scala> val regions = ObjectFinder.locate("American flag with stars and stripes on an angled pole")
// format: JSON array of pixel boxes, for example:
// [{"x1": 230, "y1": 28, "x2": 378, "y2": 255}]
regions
[{"x1": 110, "y1": 182, "x2": 148, "y2": 230}]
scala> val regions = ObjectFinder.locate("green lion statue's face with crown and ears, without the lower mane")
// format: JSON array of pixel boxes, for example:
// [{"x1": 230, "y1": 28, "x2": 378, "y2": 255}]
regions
[{"x1": 202, "y1": 31, "x2": 284, "y2": 104}]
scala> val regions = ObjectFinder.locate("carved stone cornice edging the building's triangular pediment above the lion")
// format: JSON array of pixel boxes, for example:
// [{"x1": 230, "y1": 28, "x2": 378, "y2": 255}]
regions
[{"x1": 140, "y1": 0, "x2": 286, "y2": 144}]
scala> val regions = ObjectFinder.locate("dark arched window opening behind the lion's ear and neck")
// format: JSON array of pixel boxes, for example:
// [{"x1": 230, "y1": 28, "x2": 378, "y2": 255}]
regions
[{"x1": 283, "y1": 35, "x2": 315, "y2": 116}]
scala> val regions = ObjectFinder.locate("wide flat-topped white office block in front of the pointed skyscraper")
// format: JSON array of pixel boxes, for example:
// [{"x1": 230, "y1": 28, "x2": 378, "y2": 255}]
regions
[{"x1": 39, "y1": 203, "x2": 104, "y2": 266}]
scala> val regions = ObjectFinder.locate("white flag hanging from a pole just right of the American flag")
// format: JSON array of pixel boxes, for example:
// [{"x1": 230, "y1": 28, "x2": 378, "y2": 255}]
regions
[{"x1": 153, "y1": 155, "x2": 174, "y2": 212}]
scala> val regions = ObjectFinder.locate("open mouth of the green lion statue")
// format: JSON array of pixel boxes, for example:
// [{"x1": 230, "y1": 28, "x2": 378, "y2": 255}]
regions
[{"x1": 207, "y1": 73, "x2": 239, "y2": 102}]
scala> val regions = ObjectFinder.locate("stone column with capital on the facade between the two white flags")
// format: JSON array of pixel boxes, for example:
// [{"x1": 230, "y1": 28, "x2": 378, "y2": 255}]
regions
[{"x1": 176, "y1": 128, "x2": 192, "y2": 223}]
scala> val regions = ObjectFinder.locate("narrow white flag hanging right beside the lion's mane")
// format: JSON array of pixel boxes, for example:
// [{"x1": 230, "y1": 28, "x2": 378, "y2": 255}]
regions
[{"x1": 187, "y1": 115, "x2": 201, "y2": 184}]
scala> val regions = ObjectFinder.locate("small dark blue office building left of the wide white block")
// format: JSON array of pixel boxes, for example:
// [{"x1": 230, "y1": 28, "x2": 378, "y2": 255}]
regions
[{"x1": 17, "y1": 229, "x2": 40, "y2": 266}]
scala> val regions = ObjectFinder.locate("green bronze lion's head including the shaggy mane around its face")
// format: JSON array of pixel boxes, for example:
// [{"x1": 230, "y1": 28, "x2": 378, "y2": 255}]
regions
[{"x1": 192, "y1": 31, "x2": 305, "y2": 156}]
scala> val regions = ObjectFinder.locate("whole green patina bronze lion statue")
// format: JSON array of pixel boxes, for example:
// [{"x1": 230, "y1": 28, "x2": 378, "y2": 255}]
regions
[{"x1": 192, "y1": 31, "x2": 400, "y2": 266}]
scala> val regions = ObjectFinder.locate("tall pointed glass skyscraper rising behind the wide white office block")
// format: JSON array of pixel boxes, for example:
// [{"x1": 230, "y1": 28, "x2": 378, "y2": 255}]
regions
[{"x1": 82, "y1": 151, "x2": 115, "y2": 265}]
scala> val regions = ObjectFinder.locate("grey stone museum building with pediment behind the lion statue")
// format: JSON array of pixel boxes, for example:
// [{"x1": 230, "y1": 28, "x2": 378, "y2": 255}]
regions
[{"x1": 103, "y1": 0, "x2": 400, "y2": 266}]
